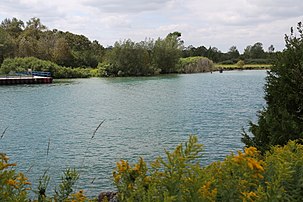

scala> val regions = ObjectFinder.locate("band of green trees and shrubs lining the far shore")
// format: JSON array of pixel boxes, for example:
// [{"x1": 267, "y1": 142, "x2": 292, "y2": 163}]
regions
[{"x1": 0, "y1": 18, "x2": 277, "y2": 78}]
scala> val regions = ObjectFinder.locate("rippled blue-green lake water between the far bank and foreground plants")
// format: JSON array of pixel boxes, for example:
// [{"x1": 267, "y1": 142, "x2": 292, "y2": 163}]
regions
[{"x1": 0, "y1": 70, "x2": 266, "y2": 196}]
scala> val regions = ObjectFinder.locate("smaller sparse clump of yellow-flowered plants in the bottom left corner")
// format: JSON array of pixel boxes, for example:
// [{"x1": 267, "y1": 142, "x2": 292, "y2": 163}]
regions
[{"x1": 0, "y1": 153, "x2": 96, "y2": 202}]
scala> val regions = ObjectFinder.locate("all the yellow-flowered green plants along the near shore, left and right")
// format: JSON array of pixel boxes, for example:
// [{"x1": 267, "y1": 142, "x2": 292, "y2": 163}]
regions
[{"x1": 0, "y1": 136, "x2": 303, "y2": 202}]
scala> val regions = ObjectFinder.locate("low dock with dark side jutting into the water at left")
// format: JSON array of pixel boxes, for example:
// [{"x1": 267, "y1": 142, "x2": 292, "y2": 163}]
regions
[{"x1": 0, "y1": 76, "x2": 53, "y2": 85}]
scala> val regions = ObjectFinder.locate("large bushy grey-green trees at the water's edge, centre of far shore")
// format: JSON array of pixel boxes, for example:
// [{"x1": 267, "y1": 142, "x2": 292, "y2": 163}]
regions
[{"x1": 102, "y1": 32, "x2": 183, "y2": 76}]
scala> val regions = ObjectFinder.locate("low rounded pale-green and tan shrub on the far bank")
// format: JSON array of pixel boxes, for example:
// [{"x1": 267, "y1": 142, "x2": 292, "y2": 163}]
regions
[{"x1": 178, "y1": 56, "x2": 215, "y2": 73}]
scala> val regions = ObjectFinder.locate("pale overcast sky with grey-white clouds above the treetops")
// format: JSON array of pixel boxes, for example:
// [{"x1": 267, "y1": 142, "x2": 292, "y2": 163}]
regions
[{"x1": 0, "y1": 0, "x2": 303, "y2": 52}]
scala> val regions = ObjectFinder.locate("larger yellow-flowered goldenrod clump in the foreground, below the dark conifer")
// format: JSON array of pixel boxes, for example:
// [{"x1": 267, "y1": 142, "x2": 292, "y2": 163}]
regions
[{"x1": 114, "y1": 136, "x2": 303, "y2": 201}]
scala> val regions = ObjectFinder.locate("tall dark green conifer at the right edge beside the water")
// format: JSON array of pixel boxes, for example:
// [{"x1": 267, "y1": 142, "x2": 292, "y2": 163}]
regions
[{"x1": 242, "y1": 22, "x2": 303, "y2": 152}]
